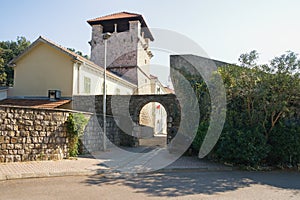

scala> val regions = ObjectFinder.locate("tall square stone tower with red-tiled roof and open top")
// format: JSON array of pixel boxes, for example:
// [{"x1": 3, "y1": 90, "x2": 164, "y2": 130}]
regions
[{"x1": 87, "y1": 12, "x2": 154, "y2": 94}]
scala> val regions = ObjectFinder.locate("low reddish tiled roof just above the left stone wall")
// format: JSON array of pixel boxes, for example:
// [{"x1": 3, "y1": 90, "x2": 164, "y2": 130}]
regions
[{"x1": 0, "y1": 99, "x2": 71, "y2": 109}]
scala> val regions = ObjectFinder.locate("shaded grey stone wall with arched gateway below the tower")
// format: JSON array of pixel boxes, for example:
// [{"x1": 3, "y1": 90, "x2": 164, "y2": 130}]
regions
[{"x1": 73, "y1": 94, "x2": 181, "y2": 152}]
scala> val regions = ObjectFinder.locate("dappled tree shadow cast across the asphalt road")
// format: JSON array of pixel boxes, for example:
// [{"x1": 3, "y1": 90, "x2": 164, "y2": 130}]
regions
[{"x1": 82, "y1": 171, "x2": 300, "y2": 197}]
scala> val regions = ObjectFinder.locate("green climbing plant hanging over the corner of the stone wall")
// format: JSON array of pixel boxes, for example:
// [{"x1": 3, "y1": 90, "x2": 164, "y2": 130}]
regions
[{"x1": 66, "y1": 113, "x2": 88, "y2": 157}]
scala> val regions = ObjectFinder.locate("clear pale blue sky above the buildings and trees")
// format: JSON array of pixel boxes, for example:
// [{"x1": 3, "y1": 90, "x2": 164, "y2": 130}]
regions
[{"x1": 0, "y1": 0, "x2": 300, "y2": 84}]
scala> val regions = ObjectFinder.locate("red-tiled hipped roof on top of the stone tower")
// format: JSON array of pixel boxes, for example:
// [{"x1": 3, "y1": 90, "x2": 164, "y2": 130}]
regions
[{"x1": 87, "y1": 12, "x2": 154, "y2": 41}]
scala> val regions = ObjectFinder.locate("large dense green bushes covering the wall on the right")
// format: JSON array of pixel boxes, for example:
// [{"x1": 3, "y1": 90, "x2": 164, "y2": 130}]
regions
[{"x1": 190, "y1": 51, "x2": 300, "y2": 167}]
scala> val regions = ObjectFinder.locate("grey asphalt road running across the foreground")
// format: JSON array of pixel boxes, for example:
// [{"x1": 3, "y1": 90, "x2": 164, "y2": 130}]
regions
[{"x1": 0, "y1": 171, "x2": 300, "y2": 200}]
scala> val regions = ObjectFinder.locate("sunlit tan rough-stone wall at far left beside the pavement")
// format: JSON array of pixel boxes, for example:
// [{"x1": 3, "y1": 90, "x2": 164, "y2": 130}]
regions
[{"x1": 0, "y1": 106, "x2": 72, "y2": 162}]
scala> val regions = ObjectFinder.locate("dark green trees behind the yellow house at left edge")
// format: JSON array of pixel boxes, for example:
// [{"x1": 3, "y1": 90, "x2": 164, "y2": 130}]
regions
[{"x1": 0, "y1": 37, "x2": 30, "y2": 86}]
